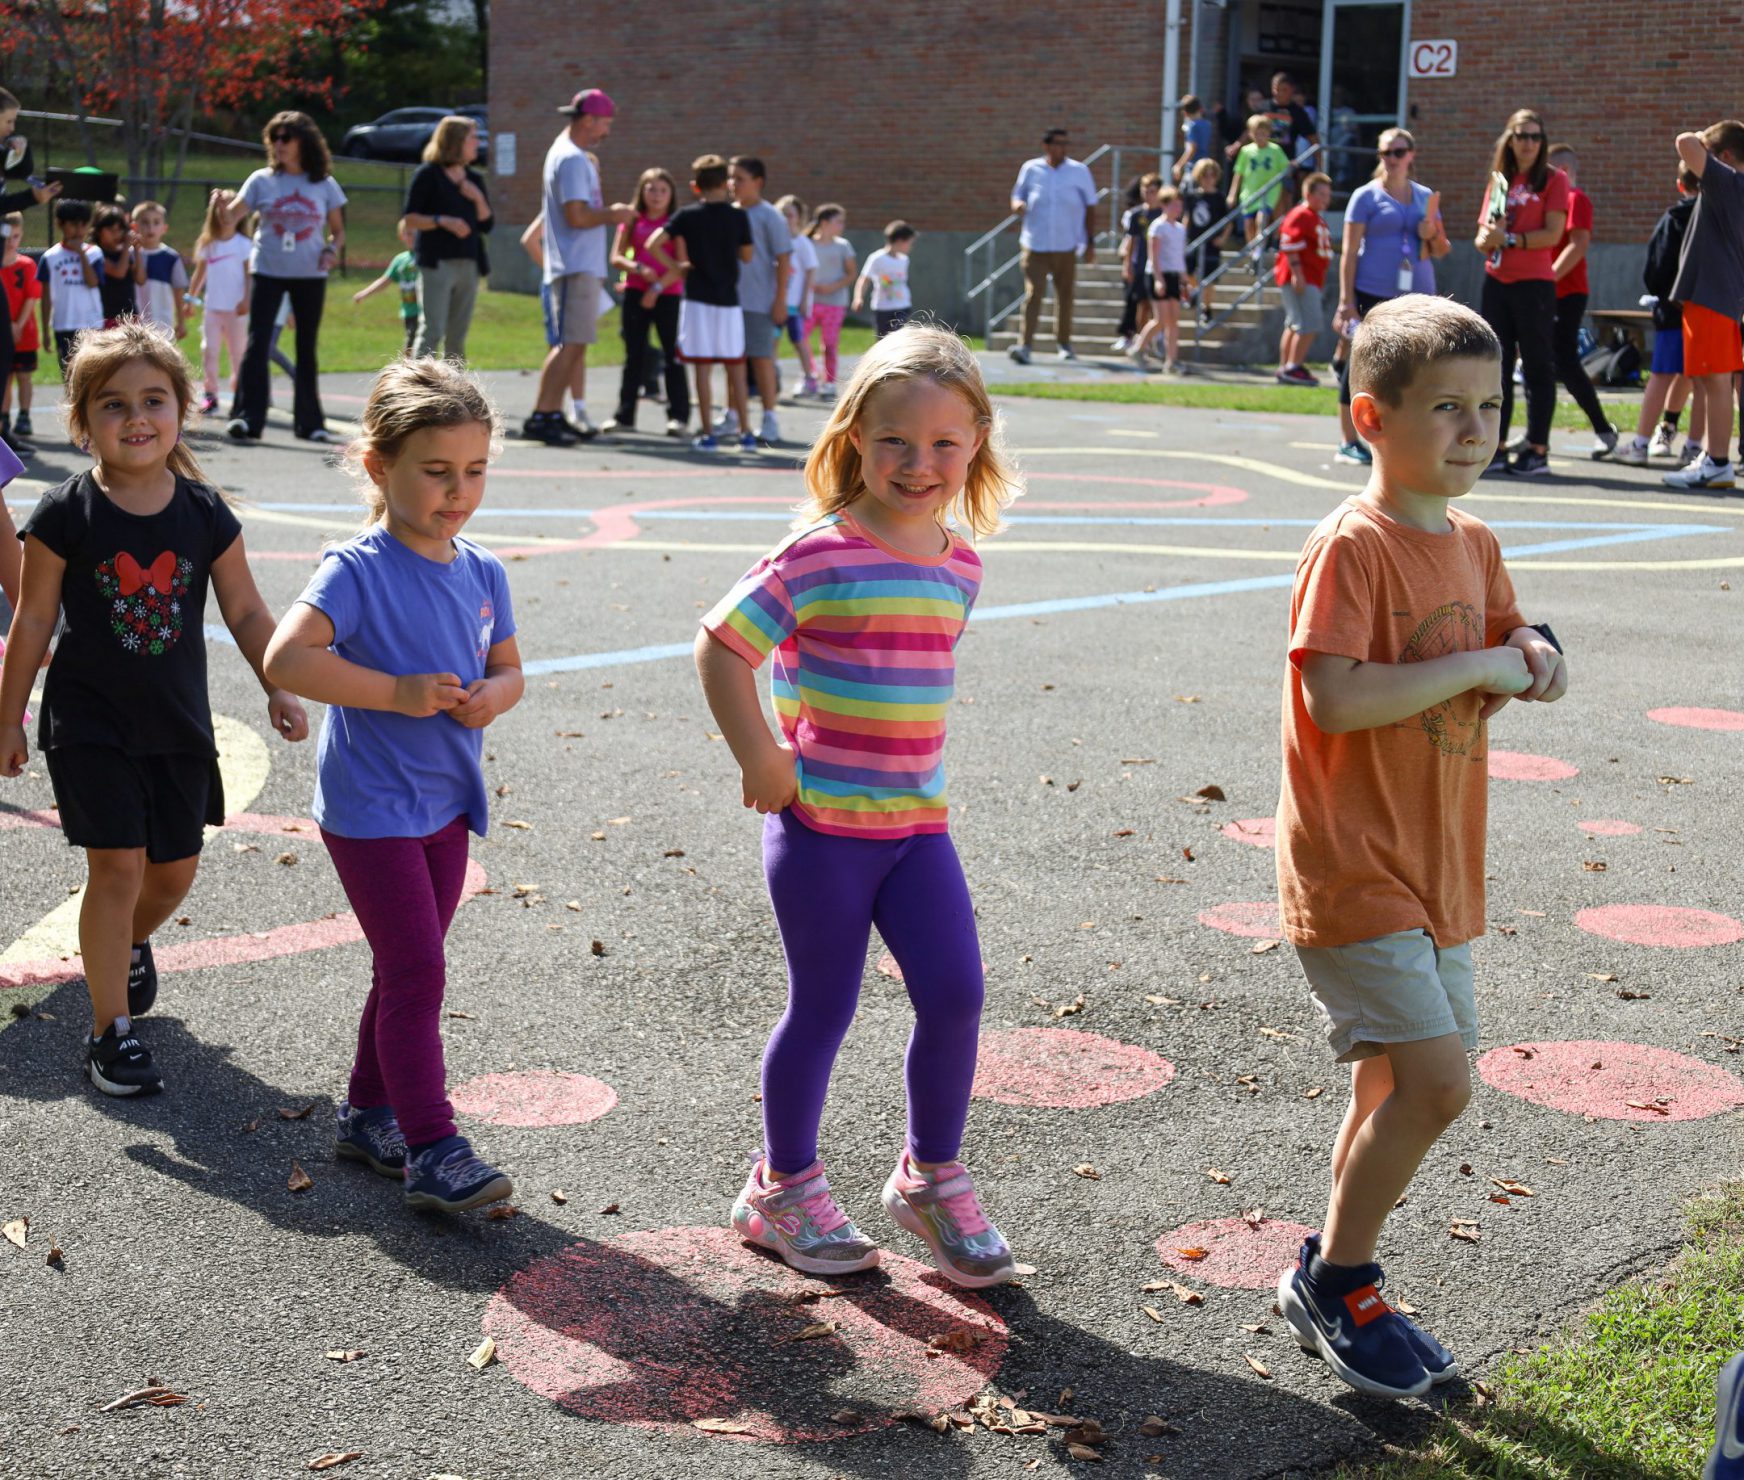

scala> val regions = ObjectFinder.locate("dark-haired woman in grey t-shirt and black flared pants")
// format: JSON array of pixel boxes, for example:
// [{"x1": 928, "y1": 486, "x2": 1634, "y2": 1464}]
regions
[{"x1": 212, "y1": 112, "x2": 345, "y2": 443}]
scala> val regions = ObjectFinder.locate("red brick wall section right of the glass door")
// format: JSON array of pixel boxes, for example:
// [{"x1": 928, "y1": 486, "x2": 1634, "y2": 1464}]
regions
[{"x1": 1409, "y1": 0, "x2": 1744, "y2": 242}]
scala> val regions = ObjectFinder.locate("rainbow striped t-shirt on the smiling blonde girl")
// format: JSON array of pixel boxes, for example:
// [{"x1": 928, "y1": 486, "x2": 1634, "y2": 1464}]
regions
[{"x1": 703, "y1": 513, "x2": 982, "y2": 838}]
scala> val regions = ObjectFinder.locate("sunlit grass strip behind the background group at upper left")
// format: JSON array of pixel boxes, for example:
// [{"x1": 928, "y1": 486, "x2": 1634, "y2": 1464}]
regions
[{"x1": 35, "y1": 285, "x2": 872, "y2": 383}]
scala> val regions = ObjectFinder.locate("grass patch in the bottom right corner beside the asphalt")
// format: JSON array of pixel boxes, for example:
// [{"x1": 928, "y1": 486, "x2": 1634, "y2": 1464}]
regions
[{"x1": 1339, "y1": 1184, "x2": 1744, "y2": 1480}]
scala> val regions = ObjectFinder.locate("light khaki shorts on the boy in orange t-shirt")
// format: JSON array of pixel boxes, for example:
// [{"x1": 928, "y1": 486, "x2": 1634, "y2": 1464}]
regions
[{"x1": 1296, "y1": 931, "x2": 1477, "y2": 1063}]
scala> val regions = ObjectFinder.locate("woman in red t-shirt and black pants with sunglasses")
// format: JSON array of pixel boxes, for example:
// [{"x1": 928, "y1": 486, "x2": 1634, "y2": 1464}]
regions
[{"x1": 1474, "y1": 108, "x2": 1568, "y2": 478}]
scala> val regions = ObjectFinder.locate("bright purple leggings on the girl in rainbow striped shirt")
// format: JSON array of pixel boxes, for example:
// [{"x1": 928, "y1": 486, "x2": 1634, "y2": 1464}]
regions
[{"x1": 762, "y1": 811, "x2": 982, "y2": 1173}]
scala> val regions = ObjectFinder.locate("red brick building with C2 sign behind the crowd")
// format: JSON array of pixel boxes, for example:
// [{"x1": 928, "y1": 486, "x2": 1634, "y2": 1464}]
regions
[{"x1": 490, "y1": 0, "x2": 1744, "y2": 312}]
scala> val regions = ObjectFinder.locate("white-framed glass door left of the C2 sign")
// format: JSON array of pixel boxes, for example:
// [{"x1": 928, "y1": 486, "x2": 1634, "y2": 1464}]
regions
[{"x1": 1320, "y1": 0, "x2": 1409, "y2": 197}]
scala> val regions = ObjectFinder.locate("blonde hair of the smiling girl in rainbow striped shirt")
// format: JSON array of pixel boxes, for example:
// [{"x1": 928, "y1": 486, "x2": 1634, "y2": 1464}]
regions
[{"x1": 799, "y1": 322, "x2": 1024, "y2": 537}]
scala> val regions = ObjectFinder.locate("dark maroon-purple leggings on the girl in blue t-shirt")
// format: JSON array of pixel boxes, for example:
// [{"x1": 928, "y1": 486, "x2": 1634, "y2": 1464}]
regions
[{"x1": 321, "y1": 816, "x2": 467, "y2": 1145}]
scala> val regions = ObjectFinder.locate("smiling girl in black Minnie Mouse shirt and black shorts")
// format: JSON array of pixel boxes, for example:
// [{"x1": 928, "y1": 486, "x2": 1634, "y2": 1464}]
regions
[{"x1": 0, "y1": 319, "x2": 309, "y2": 1095}]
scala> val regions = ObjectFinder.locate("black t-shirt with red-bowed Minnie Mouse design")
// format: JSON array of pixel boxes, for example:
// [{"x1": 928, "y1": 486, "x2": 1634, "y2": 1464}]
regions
[{"x1": 19, "y1": 472, "x2": 242, "y2": 757}]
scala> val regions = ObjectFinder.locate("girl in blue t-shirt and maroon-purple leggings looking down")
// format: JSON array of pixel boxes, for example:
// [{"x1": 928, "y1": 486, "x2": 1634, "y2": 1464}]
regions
[{"x1": 267, "y1": 359, "x2": 523, "y2": 1213}]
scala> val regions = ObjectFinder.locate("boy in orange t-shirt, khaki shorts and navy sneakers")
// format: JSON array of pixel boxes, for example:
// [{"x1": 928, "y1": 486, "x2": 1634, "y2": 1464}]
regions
[{"x1": 1278, "y1": 295, "x2": 1568, "y2": 1398}]
